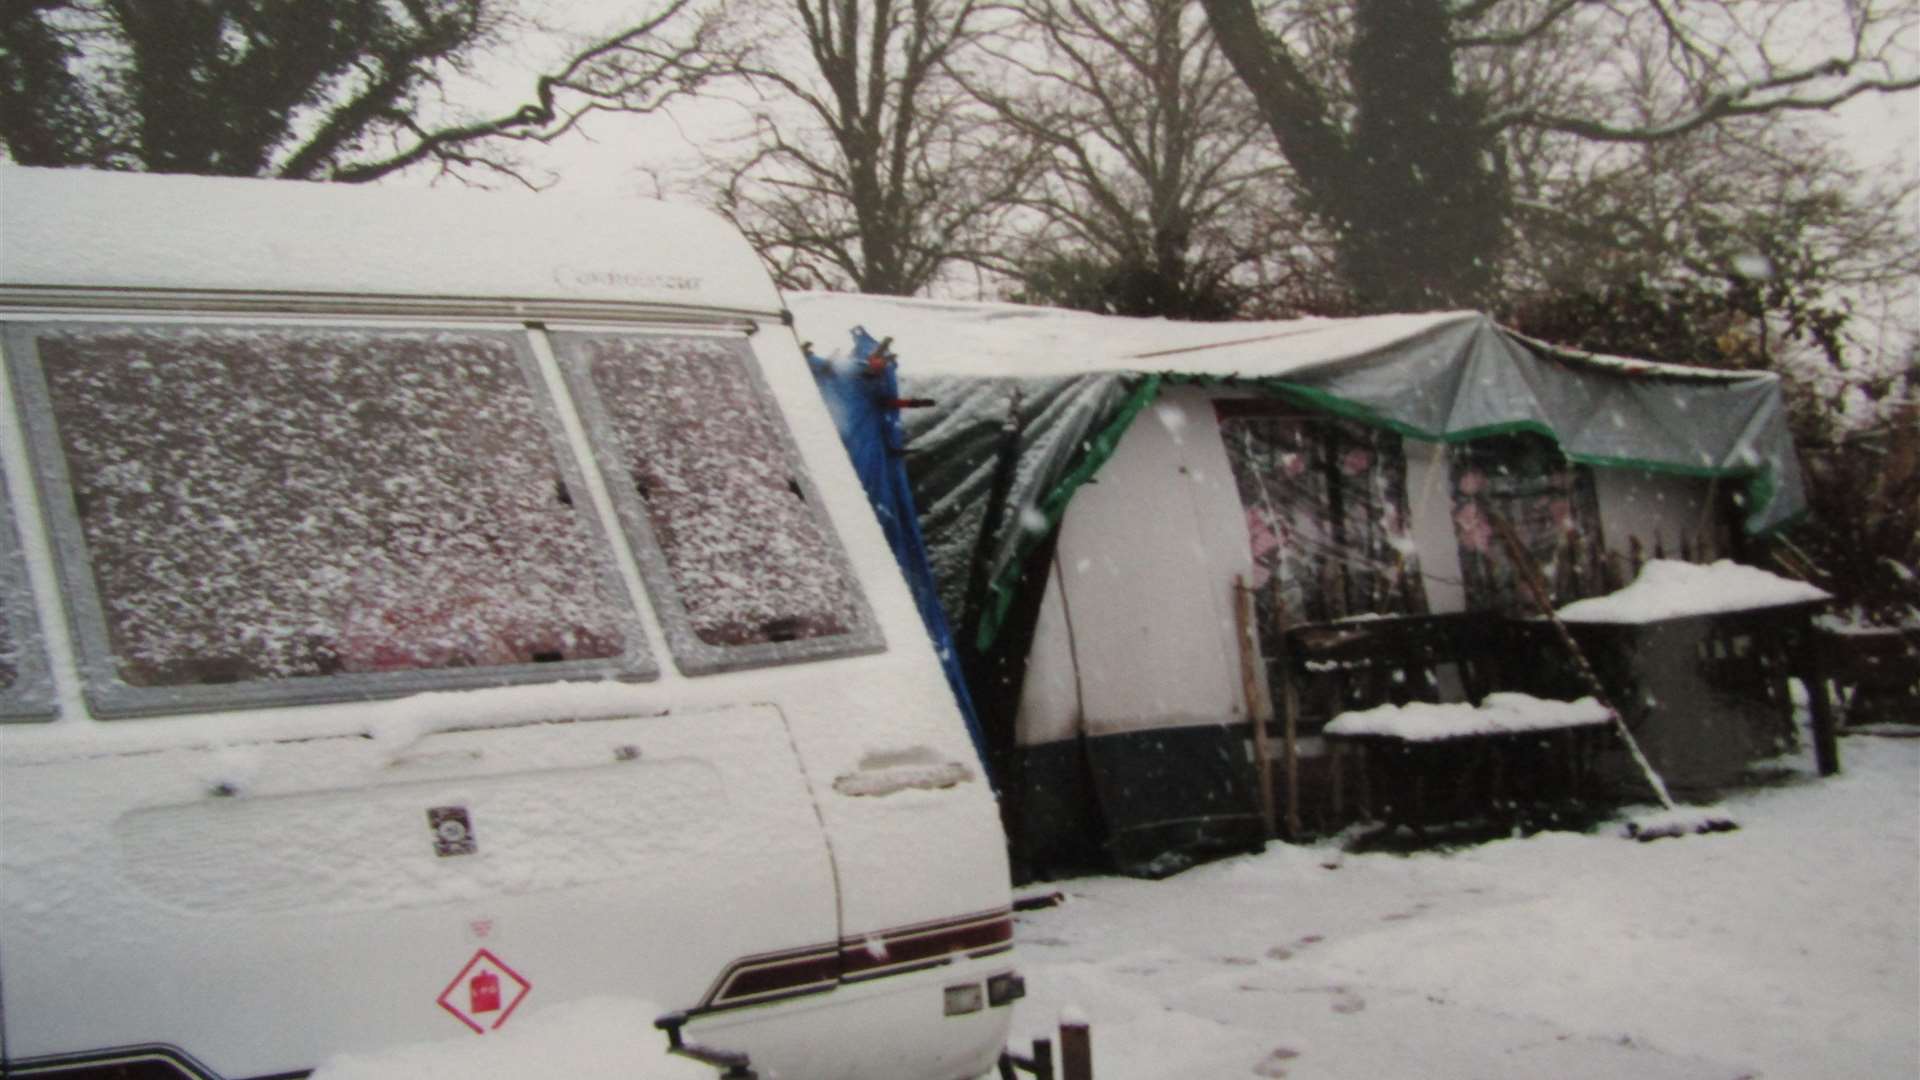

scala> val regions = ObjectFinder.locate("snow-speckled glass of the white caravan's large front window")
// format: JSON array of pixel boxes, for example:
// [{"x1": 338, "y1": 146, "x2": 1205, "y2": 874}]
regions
[{"x1": 38, "y1": 325, "x2": 626, "y2": 686}]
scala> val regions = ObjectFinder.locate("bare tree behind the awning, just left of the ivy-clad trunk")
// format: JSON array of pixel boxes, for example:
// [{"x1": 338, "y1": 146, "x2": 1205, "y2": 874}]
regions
[{"x1": 964, "y1": 0, "x2": 1286, "y2": 317}]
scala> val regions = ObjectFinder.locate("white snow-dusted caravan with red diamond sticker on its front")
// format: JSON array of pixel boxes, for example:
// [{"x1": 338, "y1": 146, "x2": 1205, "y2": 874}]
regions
[{"x1": 0, "y1": 169, "x2": 1020, "y2": 1080}]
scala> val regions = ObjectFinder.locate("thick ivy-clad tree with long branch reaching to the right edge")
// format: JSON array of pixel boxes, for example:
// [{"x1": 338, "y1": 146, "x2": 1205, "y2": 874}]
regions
[{"x1": 1202, "y1": 0, "x2": 1920, "y2": 306}]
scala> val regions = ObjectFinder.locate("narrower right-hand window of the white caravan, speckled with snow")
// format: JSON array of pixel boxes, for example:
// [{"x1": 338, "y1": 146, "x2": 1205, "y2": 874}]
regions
[{"x1": 555, "y1": 332, "x2": 879, "y2": 673}]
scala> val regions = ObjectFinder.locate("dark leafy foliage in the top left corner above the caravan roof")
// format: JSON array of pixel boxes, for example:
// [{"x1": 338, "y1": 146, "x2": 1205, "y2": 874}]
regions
[{"x1": 0, "y1": 0, "x2": 493, "y2": 177}]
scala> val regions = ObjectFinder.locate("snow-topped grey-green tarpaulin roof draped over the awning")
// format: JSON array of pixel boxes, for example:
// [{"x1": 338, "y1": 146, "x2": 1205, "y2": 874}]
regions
[{"x1": 787, "y1": 294, "x2": 1807, "y2": 644}]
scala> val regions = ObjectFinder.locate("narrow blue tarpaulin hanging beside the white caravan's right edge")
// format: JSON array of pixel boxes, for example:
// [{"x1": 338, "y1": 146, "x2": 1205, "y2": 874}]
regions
[{"x1": 806, "y1": 327, "x2": 991, "y2": 773}]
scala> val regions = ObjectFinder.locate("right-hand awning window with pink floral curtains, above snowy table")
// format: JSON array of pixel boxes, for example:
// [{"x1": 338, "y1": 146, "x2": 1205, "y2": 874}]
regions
[{"x1": 1452, "y1": 432, "x2": 1611, "y2": 613}]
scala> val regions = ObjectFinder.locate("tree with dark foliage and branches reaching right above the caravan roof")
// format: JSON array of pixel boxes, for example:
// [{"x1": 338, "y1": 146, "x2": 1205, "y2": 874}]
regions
[{"x1": 0, "y1": 0, "x2": 720, "y2": 181}]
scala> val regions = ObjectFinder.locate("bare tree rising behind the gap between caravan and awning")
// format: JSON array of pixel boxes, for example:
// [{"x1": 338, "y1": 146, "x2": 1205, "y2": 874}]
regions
[{"x1": 716, "y1": 0, "x2": 1031, "y2": 296}]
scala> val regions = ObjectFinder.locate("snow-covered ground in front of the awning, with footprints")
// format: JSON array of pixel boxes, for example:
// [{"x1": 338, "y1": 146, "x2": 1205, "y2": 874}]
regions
[{"x1": 1014, "y1": 718, "x2": 1920, "y2": 1080}]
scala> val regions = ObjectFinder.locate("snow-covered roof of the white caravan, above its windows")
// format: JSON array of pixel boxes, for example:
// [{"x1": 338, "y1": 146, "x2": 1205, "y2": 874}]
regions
[{"x1": 0, "y1": 167, "x2": 780, "y2": 315}]
